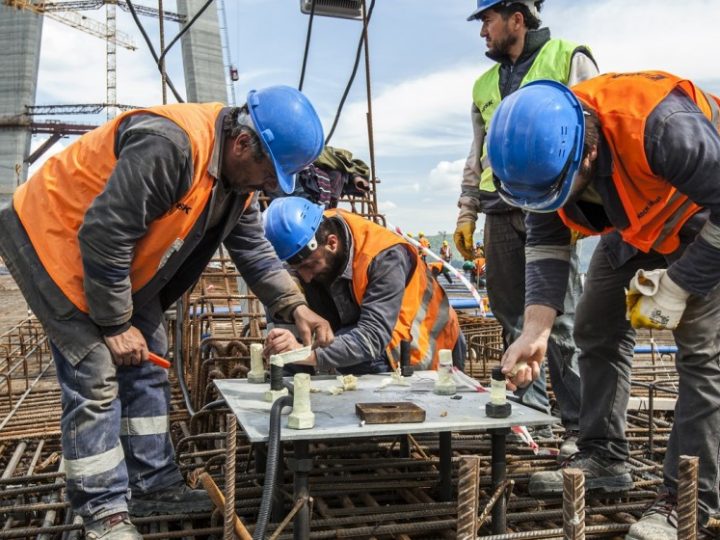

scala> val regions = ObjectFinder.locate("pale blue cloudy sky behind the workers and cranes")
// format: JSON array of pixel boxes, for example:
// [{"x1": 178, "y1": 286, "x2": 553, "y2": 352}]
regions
[{"x1": 35, "y1": 0, "x2": 720, "y2": 234}]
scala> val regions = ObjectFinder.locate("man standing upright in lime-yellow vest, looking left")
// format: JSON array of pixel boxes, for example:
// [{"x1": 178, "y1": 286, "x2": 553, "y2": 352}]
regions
[{"x1": 454, "y1": 0, "x2": 597, "y2": 460}]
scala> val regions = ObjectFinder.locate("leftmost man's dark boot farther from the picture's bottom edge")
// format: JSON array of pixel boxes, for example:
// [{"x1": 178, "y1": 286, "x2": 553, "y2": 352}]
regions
[{"x1": 128, "y1": 482, "x2": 213, "y2": 516}]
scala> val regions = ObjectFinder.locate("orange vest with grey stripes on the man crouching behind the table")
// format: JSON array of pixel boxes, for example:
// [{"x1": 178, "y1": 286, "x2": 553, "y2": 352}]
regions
[{"x1": 325, "y1": 210, "x2": 460, "y2": 369}]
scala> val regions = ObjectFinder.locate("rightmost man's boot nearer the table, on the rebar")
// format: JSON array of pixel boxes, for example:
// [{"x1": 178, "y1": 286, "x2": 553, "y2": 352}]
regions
[{"x1": 528, "y1": 452, "x2": 633, "y2": 497}]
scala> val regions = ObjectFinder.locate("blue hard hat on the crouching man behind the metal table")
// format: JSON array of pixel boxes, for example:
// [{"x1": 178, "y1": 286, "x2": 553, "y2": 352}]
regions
[{"x1": 263, "y1": 197, "x2": 323, "y2": 264}]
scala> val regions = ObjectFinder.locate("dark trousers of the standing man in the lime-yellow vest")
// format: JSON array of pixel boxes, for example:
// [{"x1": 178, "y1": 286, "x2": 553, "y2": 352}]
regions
[{"x1": 484, "y1": 209, "x2": 580, "y2": 430}]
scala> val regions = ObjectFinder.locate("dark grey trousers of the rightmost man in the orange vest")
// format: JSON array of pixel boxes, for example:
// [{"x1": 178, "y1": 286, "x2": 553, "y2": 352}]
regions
[{"x1": 575, "y1": 241, "x2": 720, "y2": 521}]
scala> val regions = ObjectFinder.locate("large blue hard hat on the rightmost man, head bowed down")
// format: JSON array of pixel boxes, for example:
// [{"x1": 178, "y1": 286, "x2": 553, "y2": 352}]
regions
[{"x1": 487, "y1": 80, "x2": 585, "y2": 212}]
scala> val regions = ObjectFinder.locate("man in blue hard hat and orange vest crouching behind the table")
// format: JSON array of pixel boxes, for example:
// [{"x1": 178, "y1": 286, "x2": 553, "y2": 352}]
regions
[{"x1": 265, "y1": 197, "x2": 466, "y2": 375}]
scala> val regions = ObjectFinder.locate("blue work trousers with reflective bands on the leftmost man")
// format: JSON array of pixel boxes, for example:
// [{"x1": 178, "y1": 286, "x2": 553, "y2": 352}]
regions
[{"x1": 51, "y1": 304, "x2": 182, "y2": 519}]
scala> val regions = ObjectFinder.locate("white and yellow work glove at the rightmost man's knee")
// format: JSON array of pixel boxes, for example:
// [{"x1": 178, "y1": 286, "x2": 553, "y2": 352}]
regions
[{"x1": 625, "y1": 269, "x2": 690, "y2": 330}]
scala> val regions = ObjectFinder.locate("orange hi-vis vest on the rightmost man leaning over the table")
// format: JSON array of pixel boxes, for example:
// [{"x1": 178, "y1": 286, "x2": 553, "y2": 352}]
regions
[{"x1": 558, "y1": 71, "x2": 720, "y2": 254}]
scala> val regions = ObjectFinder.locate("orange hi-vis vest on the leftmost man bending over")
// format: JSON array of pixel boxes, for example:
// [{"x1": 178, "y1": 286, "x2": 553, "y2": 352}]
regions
[{"x1": 13, "y1": 103, "x2": 228, "y2": 313}]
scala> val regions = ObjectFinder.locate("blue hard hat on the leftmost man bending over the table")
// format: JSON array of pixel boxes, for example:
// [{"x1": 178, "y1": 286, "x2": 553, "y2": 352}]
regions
[{"x1": 247, "y1": 86, "x2": 325, "y2": 193}]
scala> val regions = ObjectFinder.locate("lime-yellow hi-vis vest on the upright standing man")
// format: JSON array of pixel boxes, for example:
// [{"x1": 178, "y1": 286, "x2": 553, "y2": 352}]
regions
[{"x1": 473, "y1": 39, "x2": 589, "y2": 191}]
